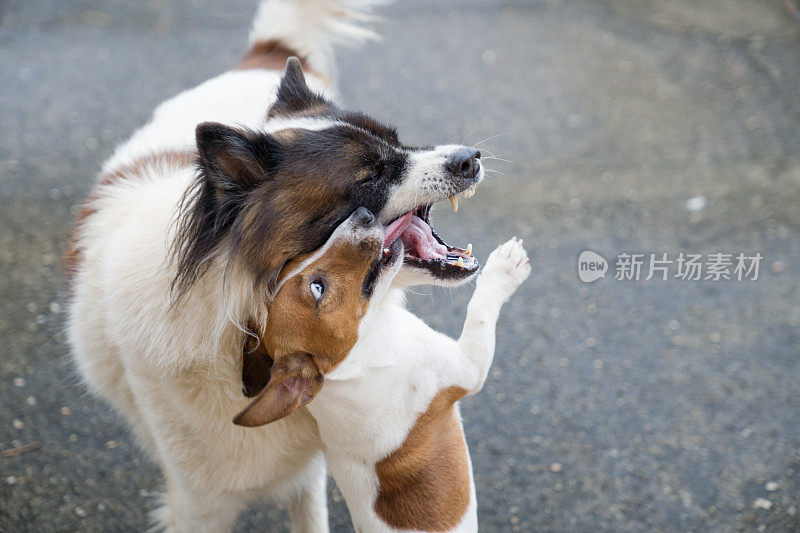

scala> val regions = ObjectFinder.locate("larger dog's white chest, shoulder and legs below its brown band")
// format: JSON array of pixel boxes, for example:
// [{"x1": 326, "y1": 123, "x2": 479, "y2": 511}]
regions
[{"x1": 68, "y1": 160, "x2": 327, "y2": 531}]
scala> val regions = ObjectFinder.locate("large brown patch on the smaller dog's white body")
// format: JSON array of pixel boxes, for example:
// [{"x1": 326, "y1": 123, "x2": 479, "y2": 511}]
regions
[{"x1": 375, "y1": 386, "x2": 470, "y2": 531}]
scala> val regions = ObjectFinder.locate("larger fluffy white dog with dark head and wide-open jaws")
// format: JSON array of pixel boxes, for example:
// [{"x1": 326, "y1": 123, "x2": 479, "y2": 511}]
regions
[{"x1": 66, "y1": 0, "x2": 494, "y2": 531}]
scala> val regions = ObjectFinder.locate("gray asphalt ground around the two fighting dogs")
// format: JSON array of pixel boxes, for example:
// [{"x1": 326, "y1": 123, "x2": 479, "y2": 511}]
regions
[{"x1": 0, "y1": 0, "x2": 800, "y2": 532}]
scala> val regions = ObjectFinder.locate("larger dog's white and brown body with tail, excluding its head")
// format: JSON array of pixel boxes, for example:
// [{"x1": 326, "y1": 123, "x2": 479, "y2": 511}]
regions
[{"x1": 65, "y1": 0, "x2": 382, "y2": 530}]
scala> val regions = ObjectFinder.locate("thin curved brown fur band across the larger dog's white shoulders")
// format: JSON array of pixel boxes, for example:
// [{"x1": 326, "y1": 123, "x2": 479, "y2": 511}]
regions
[{"x1": 63, "y1": 150, "x2": 197, "y2": 281}]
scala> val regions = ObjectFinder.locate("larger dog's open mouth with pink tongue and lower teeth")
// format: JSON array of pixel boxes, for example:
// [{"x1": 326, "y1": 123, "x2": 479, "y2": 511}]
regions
[{"x1": 383, "y1": 200, "x2": 478, "y2": 278}]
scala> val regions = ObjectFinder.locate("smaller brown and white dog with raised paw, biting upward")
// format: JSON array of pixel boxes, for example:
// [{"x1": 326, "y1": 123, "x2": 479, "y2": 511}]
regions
[{"x1": 234, "y1": 221, "x2": 530, "y2": 531}]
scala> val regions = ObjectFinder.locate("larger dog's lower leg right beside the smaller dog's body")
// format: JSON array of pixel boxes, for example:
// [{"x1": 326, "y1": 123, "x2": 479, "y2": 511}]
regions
[{"x1": 288, "y1": 453, "x2": 328, "y2": 533}]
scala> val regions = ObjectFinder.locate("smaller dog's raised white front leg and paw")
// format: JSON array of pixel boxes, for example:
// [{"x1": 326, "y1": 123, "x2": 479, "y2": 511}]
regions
[{"x1": 458, "y1": 237, "x2": 531, "y2": 394}]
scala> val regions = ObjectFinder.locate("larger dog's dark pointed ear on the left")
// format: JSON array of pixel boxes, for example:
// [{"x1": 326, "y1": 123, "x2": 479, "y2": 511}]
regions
[{"x1": 195, "y1": 122, "x2": 280, "y2": 193}]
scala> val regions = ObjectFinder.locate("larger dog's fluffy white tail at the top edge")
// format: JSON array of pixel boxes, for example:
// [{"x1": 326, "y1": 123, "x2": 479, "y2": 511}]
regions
[{"x1": 250, "y1": 0, "x2": 386, "y2": 78}]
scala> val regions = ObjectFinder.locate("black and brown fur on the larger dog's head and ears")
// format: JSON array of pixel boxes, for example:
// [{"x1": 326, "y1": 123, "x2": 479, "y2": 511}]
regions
[{"x1": 172, "y1": 58, "x2": 408, "y2": 297}]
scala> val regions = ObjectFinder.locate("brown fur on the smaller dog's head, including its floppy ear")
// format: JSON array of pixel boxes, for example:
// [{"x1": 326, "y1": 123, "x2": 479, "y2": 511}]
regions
[{"x1": 234, "y1": 219, "x2": 383, "y2": 427}]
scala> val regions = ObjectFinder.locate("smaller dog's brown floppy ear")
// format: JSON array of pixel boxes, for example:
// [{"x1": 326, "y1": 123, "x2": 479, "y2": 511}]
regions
[{"x1": 233, "y1": 353, "x2": 323, "y2": 427}]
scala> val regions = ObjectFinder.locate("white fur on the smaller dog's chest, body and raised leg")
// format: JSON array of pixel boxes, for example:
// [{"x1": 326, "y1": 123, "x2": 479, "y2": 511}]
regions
[{"x1": 309, "y1": 239, "x2": 530, "y2": 531}]
